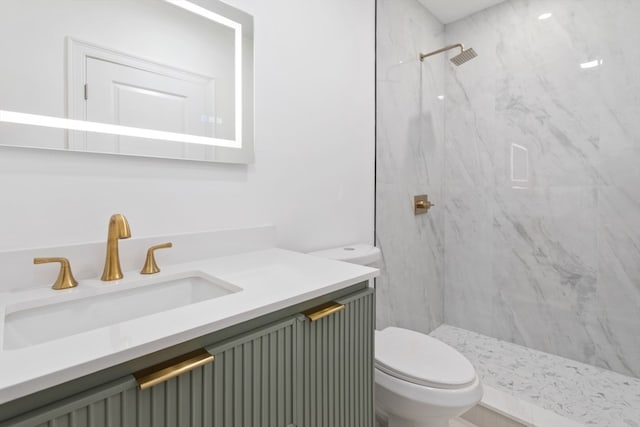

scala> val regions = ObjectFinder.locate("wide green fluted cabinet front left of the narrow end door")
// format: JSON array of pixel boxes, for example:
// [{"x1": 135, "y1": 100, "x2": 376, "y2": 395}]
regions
[{"x1": 0, "y1": 318, "x2": 298, "y2": 427}]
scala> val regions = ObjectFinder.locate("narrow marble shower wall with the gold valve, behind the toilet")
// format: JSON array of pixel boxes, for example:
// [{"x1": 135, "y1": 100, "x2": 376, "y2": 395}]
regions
[{"x1": 376, "y1": 0, "x2": 445, "y2": 332}]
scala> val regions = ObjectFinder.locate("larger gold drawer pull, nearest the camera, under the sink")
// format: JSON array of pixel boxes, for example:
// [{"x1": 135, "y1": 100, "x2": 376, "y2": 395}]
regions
[{"x1": 133, "y1": 349, "x2": 213, "y2": 390}]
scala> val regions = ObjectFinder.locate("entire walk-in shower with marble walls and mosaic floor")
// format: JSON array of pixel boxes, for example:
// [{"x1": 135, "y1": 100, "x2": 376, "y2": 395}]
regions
[{"x1": 376, "y1": 0, "x2": 640, "y2": 427}]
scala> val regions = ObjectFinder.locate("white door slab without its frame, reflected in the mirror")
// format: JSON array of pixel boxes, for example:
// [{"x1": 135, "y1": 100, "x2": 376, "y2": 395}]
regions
[{"x1": 85, "y1": 57, "x2": 215, "y2": 157}]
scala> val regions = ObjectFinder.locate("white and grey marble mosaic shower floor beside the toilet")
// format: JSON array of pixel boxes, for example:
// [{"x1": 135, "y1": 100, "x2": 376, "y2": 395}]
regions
[{"x1": 431, "y1": 325, "x2": 640, "y2": 427}]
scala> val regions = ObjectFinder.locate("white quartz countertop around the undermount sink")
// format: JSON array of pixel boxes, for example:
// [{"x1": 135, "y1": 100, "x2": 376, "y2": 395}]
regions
[{"x1": 0, "y1": 249, "x2": 378, "y2": 404}]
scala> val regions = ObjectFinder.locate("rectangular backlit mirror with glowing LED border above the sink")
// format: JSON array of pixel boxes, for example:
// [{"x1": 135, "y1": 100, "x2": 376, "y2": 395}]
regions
[{"x1": 0, "y1": 0, "x2": 253, "y2": 163}]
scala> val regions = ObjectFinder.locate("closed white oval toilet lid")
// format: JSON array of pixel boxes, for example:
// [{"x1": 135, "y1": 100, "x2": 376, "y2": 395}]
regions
[{"x1": 375, "y1": 327, "x2": 476, "y2": 389}]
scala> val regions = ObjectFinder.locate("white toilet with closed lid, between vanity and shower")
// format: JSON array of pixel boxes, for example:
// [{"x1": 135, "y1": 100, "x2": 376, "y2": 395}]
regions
[{"x1": 310, "y1": 244, "x2": 482, "y2": 427}]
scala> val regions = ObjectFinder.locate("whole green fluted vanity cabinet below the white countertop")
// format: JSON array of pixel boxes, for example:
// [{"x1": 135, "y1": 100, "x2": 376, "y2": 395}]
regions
[{"x1": 0, "y1": 284, "x2": 375, "y2": 427}]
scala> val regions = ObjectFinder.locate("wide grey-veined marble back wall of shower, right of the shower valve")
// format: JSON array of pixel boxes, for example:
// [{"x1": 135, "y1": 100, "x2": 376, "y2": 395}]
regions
[{"x1": 442, "y1": 0, "x2": 640, "y2": 376}]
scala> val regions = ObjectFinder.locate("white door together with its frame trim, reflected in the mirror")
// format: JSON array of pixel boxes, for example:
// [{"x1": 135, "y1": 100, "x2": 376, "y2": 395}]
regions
[{"x1": 68, "y1": 40, "x2": 221, "y2": 158}]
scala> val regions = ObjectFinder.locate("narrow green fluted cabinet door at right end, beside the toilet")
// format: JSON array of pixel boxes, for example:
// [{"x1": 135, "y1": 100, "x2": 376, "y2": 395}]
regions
[{"x1": 299, "y1": 289, "x2": 375, "y2": 427}]
